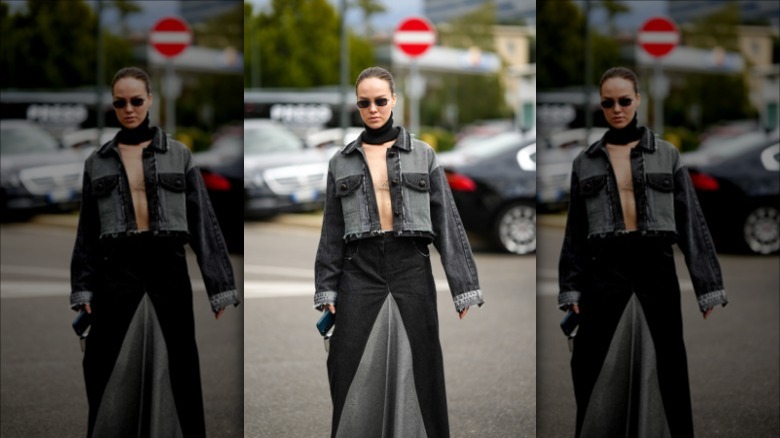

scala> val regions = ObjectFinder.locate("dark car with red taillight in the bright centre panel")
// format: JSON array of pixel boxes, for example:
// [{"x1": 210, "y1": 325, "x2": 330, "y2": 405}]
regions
[{"x1": 439, "y1": 132, "x2": 536, "y2": 254}]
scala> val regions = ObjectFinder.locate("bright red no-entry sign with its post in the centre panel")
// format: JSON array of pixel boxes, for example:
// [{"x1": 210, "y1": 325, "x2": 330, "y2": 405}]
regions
[{"x1": 393, "y1": 17, "x2": 436, "y2": 135}]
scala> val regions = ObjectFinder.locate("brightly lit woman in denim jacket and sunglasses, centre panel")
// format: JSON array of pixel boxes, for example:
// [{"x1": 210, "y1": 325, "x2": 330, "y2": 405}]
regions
[{"x1": 314, "y1": 67, "x2": 483, "y2": 437}]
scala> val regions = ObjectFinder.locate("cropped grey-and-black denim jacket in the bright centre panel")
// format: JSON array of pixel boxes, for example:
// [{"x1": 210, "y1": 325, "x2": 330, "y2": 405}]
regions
[{"x1": 314, "y1": 128, "x2": 484, "y2": 311}]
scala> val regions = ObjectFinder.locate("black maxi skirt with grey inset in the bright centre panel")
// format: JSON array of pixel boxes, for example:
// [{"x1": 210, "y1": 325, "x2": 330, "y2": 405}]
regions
[{"x1": 328, "y1": 233, "x2": 449, "y2": 438}]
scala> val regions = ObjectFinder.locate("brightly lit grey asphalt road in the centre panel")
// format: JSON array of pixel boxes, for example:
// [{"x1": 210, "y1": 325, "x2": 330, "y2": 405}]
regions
[{"x1": 244, "y1": 222, "x2": 536, "y2": 438}]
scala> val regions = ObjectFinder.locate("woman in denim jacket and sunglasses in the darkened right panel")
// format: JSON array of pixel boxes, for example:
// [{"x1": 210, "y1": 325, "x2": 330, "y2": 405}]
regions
[{"x1": 558, "y1": 67, "x2": 728, "y2": 437}]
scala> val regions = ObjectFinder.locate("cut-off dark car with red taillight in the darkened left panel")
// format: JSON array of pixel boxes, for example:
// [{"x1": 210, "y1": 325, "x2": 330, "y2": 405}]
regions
[{"x1": 193, "y1": 126, "x2": 244, "y2": 253}]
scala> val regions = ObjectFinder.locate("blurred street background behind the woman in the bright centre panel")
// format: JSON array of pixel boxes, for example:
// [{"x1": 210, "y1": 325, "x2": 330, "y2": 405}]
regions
[{"x1": 243, "y1": 0, "x2": 536, "y2": 437}]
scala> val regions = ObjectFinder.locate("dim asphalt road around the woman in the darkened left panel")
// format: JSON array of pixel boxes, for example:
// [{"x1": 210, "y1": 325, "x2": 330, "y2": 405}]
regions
[{"x1": 0, "y1": 218, "x2": 244, "y2": 438}]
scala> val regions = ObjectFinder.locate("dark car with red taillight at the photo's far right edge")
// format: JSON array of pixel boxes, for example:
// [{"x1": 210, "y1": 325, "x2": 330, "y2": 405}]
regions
[{"x1": 682, "y1": 133, "x2": 780, "y2": 254}]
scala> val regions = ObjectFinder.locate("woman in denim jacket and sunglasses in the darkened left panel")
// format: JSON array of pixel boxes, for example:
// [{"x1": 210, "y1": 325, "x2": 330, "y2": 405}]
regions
[{"x1": 70, "y1": 67, "x2": 239, "y2": 437}]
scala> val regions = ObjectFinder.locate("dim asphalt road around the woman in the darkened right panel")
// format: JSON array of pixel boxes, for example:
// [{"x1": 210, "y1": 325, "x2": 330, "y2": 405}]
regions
[{"x1": 536, "y1": 221, "x2": 780, "y2": 438}]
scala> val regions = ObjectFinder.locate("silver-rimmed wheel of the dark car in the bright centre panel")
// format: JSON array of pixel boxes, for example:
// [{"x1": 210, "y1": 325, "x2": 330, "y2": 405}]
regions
[{"x1": 493, "y1": 202, "x2": 536, "y2": 254}]
